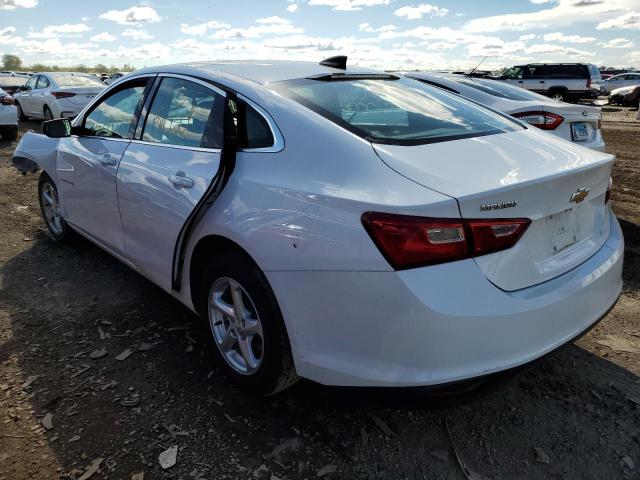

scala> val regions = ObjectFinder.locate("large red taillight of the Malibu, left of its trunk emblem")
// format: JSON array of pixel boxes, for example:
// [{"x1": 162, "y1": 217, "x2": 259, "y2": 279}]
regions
[{"x1": 362, "y1": 212, "x2": 531, "y2": 270}]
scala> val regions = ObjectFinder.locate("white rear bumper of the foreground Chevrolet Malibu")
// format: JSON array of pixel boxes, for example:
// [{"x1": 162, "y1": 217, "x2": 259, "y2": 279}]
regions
[{"x1": 267, "y1": 213, "x2": 624, "y2": 387}]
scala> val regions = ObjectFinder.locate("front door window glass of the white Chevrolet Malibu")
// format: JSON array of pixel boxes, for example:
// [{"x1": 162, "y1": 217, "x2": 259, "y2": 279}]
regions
[{"x1": 83, "y1": 82, "x2": 145, "y2": 138}]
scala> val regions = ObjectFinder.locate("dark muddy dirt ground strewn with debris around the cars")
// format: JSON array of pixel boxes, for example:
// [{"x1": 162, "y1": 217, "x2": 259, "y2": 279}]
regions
[{"x1": 0, "y1": 107, "x2": 640, "y2": 480}]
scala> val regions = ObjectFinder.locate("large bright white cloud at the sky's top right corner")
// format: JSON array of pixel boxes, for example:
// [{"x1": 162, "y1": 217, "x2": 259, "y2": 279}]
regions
[{"x1": 464, "y1": 0, "x2": 640, "y2": 32}]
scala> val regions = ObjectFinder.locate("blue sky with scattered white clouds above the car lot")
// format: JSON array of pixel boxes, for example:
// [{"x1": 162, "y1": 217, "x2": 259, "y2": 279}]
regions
[{"x1": 0, "y1": 0, "x2": 640, "y2": 70}]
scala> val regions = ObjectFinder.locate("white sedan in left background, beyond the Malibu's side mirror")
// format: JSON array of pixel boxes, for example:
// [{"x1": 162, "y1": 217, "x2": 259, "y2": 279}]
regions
[{"x1": 13, "y1": 72, "x2": 106, "y2": 120}]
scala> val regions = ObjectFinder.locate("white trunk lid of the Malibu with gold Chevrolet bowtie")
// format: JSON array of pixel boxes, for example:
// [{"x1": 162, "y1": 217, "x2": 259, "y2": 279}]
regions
[{"x1": 374, "y1": 128, "x2": 614, "y2": 291}]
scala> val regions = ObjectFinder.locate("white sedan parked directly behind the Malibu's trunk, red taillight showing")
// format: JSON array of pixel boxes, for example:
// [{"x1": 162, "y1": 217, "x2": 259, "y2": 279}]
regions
[{"x1": 404, "y1": 72, "x2": 605, "y2": 150}]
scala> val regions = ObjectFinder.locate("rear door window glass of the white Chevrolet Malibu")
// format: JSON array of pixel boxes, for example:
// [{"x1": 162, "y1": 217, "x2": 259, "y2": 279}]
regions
[{"x1": 142, "y1": 77, "x2": 224, "y2": 148}]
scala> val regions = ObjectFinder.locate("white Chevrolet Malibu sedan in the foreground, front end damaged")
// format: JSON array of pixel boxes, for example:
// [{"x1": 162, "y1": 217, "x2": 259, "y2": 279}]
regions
[{"x1": 13, "y1": 57, "x2": 623, "y2": 393}]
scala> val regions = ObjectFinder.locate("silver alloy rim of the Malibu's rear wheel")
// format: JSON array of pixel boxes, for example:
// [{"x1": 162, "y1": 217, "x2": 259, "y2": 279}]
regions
[{"x1": 209, "y1": 277, "x2": 264, "y2": 375}]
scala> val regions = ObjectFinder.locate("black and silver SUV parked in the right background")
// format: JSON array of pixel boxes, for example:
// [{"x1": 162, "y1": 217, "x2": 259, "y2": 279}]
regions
[{"x1": 498, "y1": 63, "x2": 602, "y2": 102}]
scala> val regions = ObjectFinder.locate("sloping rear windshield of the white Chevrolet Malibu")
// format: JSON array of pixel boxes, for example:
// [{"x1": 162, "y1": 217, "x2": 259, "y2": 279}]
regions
[{"x1": 271, "y1": 75, "x2": 522, "y2": 145}]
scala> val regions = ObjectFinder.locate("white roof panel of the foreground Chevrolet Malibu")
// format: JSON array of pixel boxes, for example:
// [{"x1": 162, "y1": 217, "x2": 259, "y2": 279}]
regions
[{"x1": 135, "y1": 60, "x2": 380, "y2": 84}]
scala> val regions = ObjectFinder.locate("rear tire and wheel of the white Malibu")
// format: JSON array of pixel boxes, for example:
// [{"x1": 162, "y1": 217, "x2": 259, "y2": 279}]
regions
[{"x1": 198, "y1": 251, "x2": 298, "y2": 395}]
